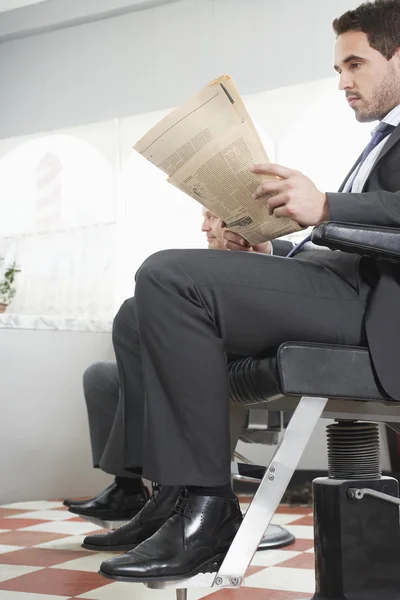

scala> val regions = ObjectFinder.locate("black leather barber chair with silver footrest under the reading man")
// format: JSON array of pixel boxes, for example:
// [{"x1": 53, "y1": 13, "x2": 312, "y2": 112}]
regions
[{"x1": 147, "y1": 223, "x2": 400, "y2": 600}]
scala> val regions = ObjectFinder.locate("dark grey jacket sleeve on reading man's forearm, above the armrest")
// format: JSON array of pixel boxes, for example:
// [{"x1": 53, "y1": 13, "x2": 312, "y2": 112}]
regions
[{"x1": 327, "y1": 190, "x2": 400, "y2": 227}]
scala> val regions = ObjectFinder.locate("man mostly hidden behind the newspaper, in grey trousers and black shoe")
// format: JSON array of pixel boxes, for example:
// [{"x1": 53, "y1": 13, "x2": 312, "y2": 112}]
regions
[{"x1": 64, "y1": 209, "x2": 269, "y2": 521}]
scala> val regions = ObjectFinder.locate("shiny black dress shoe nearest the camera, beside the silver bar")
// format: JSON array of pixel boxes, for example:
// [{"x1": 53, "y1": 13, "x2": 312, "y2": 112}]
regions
[{"x1": 99, "y1": 492, "x2": 242, "y2": 583}]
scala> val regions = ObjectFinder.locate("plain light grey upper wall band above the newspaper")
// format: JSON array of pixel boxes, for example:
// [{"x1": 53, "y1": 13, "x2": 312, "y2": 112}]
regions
[{"x1": 0, "y1": 0, "x2": 359, "y2": 138}]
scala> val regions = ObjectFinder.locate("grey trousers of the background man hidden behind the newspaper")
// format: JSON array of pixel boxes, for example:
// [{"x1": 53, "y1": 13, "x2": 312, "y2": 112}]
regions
[{"x1": 83, "y1": 360, "x2": 248, "y2": 477}]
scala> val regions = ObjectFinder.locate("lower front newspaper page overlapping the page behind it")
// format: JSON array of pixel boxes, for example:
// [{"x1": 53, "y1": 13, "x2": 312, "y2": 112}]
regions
[{"x1": 168, "y1": 125, "x2": 301, "y2": 245}]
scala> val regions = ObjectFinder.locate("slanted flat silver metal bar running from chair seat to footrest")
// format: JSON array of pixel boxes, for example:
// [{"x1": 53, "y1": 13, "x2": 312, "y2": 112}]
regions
[{"x1": 213, "y1": 396, "x2": 328, "y2": 588}]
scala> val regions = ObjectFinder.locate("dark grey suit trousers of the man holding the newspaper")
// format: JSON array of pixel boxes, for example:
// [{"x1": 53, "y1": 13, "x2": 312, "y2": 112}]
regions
[{"x1": 122, "y1": 250, "x2": 367, "y2": 486}]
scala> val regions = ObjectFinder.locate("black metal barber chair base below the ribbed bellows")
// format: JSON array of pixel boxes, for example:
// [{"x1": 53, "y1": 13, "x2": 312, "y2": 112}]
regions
[{"x1": 312, "y1": 477, "x2": 400, "y2": 600}]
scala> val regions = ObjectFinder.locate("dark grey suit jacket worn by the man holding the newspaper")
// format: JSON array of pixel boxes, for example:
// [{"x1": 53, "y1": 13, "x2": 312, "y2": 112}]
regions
[{"x1": 274, "y1": 125, "x2": 400, "y2": 400}]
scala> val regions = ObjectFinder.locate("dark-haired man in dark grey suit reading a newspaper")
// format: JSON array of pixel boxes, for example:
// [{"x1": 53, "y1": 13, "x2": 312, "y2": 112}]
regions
[{"x1": 94, "y1": 0, "x2": 400, "y2": 581}]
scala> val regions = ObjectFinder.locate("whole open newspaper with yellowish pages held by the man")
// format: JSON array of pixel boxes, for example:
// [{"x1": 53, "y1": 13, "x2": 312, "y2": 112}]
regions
[{"x1": 134, "y1": 75, "x2": 302, "y2": 245}]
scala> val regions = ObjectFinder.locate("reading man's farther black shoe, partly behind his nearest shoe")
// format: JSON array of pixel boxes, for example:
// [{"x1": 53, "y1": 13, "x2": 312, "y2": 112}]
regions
[{"x1": 82, "y1": 485, "x2": 181, "y2": 551}]
